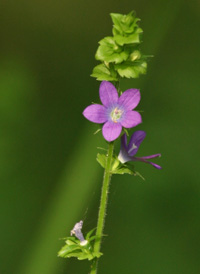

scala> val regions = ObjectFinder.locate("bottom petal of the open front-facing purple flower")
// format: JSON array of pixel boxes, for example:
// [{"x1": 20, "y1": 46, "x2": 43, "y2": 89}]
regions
[{"x1": 102, "y1": 121, "x2": 122, "y2": 142}]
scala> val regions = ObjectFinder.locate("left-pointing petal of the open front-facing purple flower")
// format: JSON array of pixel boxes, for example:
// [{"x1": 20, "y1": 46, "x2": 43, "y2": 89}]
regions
[{"x1": 83, "y1": 104, "x2": 107, "y2": 124}]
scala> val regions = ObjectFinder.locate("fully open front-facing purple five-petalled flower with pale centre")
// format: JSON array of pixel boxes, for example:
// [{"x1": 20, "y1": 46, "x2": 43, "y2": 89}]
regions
[{"x1": 83, "y1": 81, "x2": 142, "y2": 142}]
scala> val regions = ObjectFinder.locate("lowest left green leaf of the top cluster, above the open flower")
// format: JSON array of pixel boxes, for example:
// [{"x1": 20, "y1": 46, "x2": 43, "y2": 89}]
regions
[{"x1": 91, "y1": 64, "x2": 118, "y2": 81}]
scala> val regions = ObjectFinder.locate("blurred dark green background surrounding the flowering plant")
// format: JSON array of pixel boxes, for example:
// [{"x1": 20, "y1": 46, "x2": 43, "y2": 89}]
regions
[{"x1": 0, "y1": 0, "x2": 200, "y2": 274}]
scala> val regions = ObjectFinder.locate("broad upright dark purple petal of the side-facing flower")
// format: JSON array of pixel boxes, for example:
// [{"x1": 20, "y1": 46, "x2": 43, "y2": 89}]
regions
[{"x1": 127, "y1": 130, "x2": 146, "y2": 156}]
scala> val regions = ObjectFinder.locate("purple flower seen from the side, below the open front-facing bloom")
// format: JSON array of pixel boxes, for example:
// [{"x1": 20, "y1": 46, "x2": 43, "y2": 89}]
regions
[{"x1": 118, "y1": 130, "x2": 162, "y2": 169}]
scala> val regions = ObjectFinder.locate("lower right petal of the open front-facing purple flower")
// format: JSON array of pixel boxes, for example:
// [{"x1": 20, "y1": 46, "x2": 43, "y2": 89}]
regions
[{"x1": 120, "y1": 110, "x2": 142, "y2": 128}]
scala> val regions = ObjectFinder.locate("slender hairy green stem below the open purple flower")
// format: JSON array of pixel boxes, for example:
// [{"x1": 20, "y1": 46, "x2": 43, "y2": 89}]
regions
[{"x1": 90, "y1": 142, "x2": 114, "y2": 274}]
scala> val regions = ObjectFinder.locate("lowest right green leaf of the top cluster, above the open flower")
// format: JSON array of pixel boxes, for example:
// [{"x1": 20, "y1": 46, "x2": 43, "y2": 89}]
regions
[{"x1": 115, "y1": 60, "x2": 147, "y2": 78}]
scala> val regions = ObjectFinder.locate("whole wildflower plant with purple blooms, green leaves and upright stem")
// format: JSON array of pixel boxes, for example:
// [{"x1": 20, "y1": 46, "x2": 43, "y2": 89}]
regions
[{"x1": 58, "y1": 9, "x2": 161, "y2": 274}]
